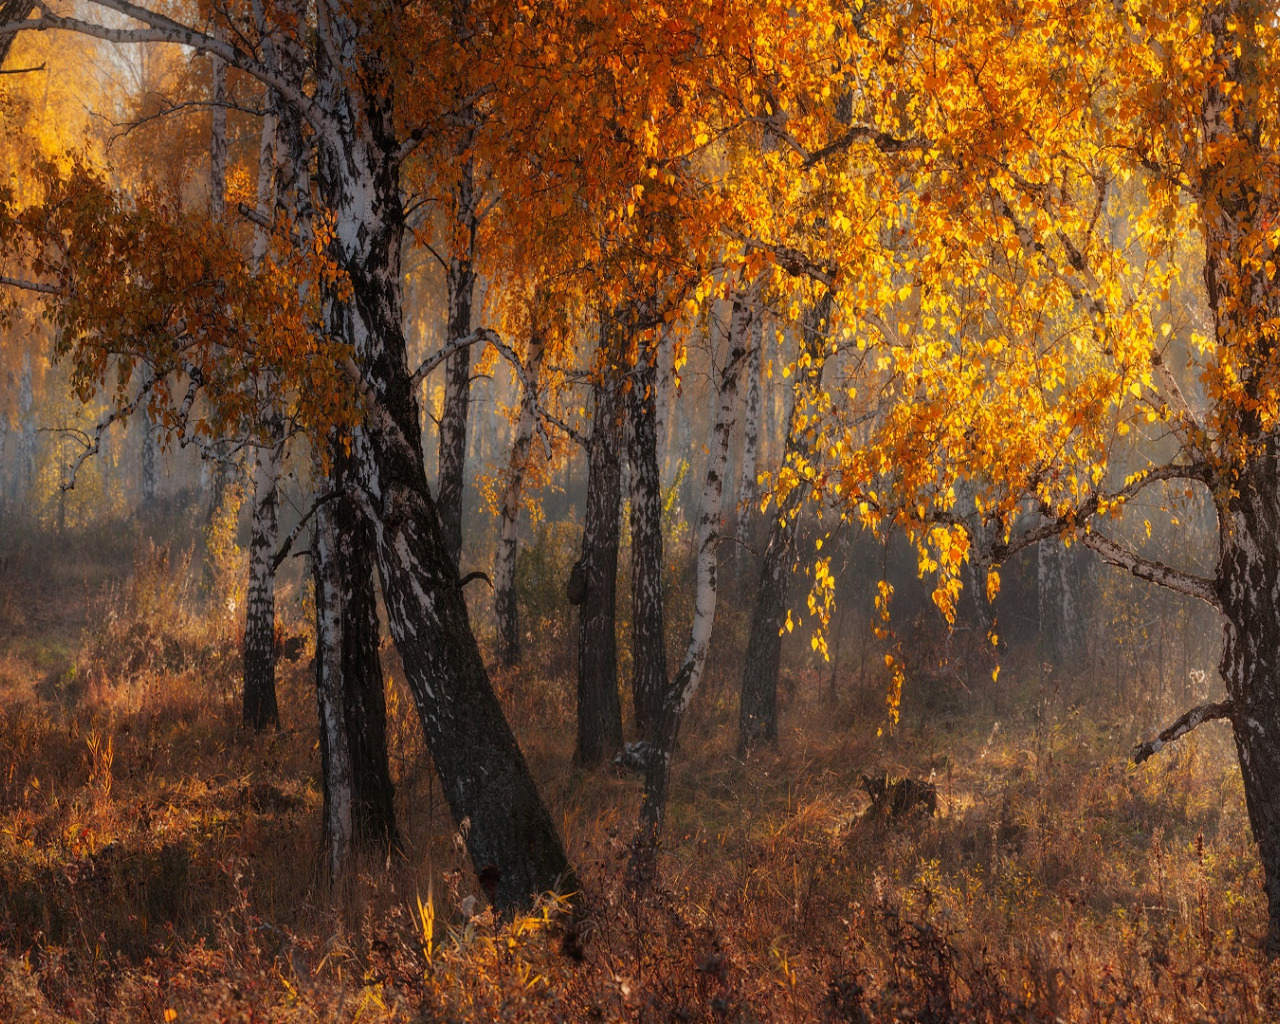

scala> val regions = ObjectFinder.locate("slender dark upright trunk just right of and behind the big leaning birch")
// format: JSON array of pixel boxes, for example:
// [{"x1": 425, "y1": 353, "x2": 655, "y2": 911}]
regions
[{"x1": 436, "y1": 160, "x2": 477, "y2": 564}]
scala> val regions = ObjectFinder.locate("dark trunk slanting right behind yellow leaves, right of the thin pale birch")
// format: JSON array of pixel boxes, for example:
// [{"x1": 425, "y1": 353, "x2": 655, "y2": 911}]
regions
[{"x1": 737, "y1": 292, "x2": 832, "y2": 755}]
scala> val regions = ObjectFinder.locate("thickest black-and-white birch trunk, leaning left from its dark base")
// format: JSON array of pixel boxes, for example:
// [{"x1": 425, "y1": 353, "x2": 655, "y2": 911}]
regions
[{"x1": 315, "y1": 0, "x2": 577, "y2": 911}]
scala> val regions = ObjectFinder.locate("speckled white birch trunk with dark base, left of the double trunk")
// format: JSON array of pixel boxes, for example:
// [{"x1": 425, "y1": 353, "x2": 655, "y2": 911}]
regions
[{"x1": 243, "y1": 417, "x2": 284, "y2": 732}]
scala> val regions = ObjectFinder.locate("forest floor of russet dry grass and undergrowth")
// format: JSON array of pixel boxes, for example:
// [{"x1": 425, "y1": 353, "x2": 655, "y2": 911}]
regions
[{"x1": 0, "y1": 524, "x2": 1280, "y2": 1024}]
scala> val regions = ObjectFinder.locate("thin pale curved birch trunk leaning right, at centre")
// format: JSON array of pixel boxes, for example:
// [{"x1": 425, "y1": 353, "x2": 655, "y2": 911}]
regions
[{"x1": 628, "y1": 279, "x2": 763, "y2": 891}]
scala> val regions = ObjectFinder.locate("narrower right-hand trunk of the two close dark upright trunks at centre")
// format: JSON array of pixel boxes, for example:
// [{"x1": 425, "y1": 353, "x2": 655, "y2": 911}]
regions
[{"x1": 627, "y1": 340, "x2": 667, "y2": 741}]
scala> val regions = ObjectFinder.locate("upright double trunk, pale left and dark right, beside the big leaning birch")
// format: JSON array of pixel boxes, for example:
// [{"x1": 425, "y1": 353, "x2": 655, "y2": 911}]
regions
[{"x1": 311, "y1": 483, "x2": 396, "y2": 879}]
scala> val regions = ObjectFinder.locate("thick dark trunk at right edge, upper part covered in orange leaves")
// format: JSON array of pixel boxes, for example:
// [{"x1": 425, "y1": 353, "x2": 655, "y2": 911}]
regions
[{"x1": 1197, "y1": 1, "x2": 1280, "y2": 956}]
